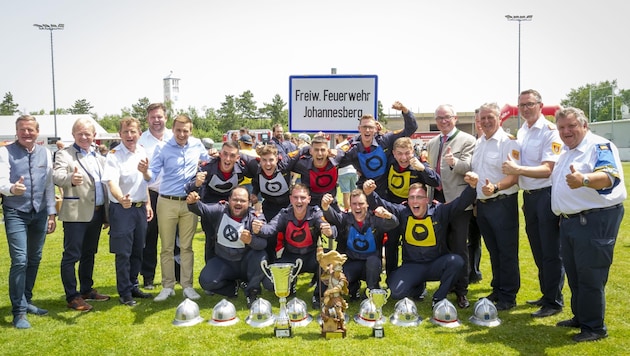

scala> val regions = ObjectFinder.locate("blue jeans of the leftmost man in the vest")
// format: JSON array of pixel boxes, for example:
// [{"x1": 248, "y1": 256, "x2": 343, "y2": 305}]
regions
[{"x1": 4, "y1": 206, "x2": 48, "y2": 316}]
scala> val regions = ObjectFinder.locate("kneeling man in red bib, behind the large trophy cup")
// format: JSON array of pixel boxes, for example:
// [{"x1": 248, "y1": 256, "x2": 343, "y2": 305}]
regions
[{"x1": 259, "y1": 183, "x2": 337, "y2": 309}]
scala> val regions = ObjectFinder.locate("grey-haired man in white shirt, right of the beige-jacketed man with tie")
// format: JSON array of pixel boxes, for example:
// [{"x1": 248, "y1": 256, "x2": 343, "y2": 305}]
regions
[{"x1": 472, "y1": 103, "x2": 521, "y2": 310}]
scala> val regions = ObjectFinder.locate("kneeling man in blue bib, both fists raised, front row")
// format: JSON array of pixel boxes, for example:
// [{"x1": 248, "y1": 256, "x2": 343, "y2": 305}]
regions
[{"x1": 321, "y1": 189, "x2": 398, "y2": 300}]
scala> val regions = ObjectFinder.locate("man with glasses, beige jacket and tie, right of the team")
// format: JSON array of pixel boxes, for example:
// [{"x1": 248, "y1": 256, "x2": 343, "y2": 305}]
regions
[{"x1": 427, "y1": 104, "x2": 475, "y2": 308}]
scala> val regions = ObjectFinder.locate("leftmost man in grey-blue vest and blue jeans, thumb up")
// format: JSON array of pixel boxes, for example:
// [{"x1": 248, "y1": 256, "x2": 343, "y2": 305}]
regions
[{"x1": 0, "y1": 115, "x2": 57, "y2": 329}]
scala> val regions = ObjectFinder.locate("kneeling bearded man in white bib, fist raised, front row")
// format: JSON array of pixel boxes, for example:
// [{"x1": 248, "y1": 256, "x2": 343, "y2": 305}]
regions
[{"x1": 186, "y1": 186, "x2": 267, "y2": 308}]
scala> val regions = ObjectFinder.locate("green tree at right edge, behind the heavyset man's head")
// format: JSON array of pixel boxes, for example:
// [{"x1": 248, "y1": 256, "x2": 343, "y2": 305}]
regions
[{"x1": 560, "y1": 80, "x2": 630, "y2": 122}]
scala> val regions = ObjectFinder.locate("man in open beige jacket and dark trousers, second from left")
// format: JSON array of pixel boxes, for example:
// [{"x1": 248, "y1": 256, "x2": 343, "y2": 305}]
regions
[{"x1": 53, "y1": 118, "x2": 109, "y2": 312}]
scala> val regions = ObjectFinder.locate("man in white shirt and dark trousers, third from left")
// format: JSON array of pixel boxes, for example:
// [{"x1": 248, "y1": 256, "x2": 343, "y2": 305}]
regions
[{"x1": 103, "y1": 117, "x2": 153, "y2": 307}]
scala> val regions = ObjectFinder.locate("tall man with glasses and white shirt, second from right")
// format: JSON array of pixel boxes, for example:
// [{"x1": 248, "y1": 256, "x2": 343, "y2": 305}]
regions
[{"x1": 502, "y1": 89, "x2": 564, "y2": 318}]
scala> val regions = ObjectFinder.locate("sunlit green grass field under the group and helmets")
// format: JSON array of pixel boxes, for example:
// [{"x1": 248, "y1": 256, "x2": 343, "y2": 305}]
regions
[{"x1": 0, "y1": 164, "x2": 630, "y2": 355}]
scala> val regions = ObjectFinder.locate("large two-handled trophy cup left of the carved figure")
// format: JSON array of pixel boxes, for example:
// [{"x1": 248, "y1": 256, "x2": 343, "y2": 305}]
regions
[{"x1": 260, "y1": 258, "x2": 302, "y2": 337}]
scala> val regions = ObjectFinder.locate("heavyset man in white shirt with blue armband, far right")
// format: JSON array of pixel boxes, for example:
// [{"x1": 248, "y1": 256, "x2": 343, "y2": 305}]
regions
[{"x1": 551, "y1": 108, "x2": 628, "y2": 342}]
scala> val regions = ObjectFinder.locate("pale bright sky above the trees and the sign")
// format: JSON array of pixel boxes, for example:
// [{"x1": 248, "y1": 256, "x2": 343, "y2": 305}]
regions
[{"x1": 0, "y1": 0, "x2": 630, "y2": 117}]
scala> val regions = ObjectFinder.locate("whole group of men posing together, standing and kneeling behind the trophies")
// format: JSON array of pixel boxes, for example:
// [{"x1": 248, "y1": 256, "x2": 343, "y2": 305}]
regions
[{"x1": 0, "y1": 90, "x2": 626, "y2": 341}]
